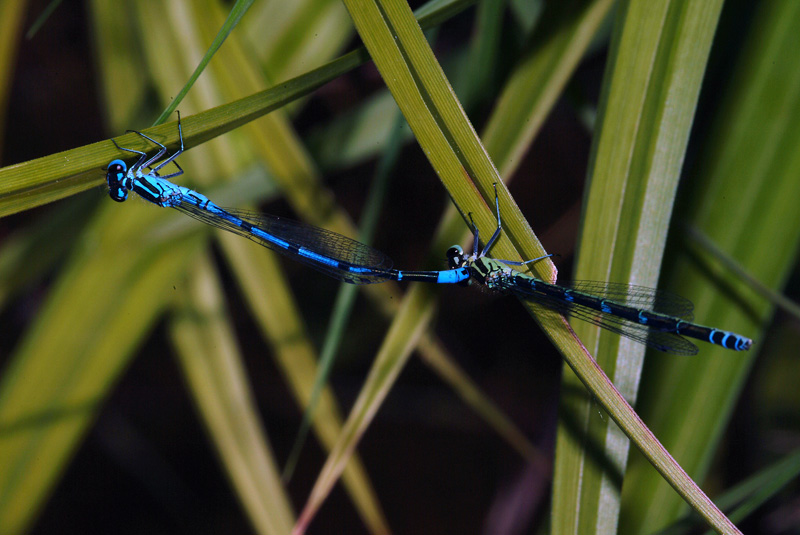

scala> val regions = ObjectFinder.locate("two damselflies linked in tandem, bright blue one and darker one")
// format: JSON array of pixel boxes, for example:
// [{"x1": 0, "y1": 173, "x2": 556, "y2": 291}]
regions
[{"x1": 106, "y1": 114, "x2": 752, "y2": 355}]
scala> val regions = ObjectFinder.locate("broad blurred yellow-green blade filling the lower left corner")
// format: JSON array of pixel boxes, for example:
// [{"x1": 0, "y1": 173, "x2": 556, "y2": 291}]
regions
[{"x1": 0, "y1": 203, "x2": 209, "y2": 533}]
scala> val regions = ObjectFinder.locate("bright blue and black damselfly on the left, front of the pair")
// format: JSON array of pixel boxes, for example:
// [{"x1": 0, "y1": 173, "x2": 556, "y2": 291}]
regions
[{"x1": 106, "y1": 114, "x2": 469, "y2": 284}]
